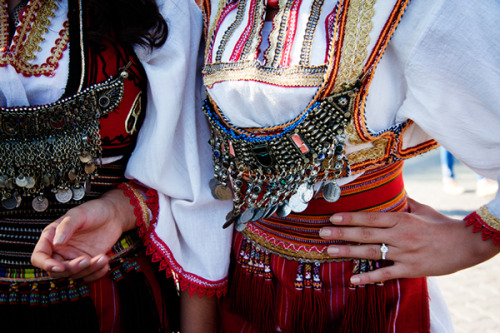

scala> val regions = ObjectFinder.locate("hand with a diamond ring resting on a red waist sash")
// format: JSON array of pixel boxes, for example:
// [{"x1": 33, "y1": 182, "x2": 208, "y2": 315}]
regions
[{"x1": 320, "y1": 199, "x2": 500, "y2": 284}]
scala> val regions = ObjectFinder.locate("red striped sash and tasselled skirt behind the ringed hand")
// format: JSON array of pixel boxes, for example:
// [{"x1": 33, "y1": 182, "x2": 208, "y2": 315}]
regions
[{"x1": 222, "y1": 162, "x2": 430, "y2": 333}]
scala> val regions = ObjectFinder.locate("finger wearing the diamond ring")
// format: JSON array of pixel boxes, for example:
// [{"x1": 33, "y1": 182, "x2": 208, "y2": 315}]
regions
[{"x1": 327, "y1": 244, "x2": 398, "y2": 260}]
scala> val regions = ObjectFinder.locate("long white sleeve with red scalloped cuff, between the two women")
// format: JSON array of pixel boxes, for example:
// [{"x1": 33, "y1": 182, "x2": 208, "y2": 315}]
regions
[{"x1": 126, "y1": 0, "x2": 232, "y2": 296}]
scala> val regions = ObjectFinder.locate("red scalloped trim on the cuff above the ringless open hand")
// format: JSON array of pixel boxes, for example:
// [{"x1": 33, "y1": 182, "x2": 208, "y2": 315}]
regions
[{"x1": 118, "y1": 181, "x2": 228, "y2": 298}]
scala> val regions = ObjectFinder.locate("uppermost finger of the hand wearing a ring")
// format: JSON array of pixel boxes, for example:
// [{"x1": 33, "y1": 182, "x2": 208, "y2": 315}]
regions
[{"x1": 330, "y1": 212, "x2": 399, "y2": 228}]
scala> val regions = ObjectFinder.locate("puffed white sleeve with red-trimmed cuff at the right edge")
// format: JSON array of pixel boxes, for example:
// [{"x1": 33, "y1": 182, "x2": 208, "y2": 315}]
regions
[{"x1": 392, "y1": 0, "x2": 500, "y2": 241}]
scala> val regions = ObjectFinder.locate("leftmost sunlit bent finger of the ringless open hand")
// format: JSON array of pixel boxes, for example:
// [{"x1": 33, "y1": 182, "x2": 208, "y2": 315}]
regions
[{"x1": 31, "y1": 223, "x2": 65, "y2": 273}]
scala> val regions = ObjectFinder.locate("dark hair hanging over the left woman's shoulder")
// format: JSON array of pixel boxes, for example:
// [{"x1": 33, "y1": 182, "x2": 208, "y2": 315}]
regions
[{"x1": 88, "y1": 0, "x2": 168, "y2": 49}]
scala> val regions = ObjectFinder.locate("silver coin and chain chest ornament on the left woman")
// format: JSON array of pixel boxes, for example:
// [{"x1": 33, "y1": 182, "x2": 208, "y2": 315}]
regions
[{"x1": 0, "y1": 65, "x2": 128, "y2": 212}]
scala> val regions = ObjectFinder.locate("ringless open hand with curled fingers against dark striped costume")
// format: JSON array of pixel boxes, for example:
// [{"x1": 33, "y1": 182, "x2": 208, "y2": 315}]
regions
[{"x1": 31, "y1": 190, "x2": 135, "y2": 281}]
